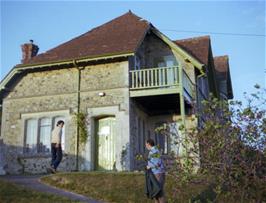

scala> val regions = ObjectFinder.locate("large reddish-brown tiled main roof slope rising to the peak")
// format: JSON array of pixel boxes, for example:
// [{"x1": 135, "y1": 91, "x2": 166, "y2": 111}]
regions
[{"x1": 20, "y1": 11, "x2": 150, "y2": 65}]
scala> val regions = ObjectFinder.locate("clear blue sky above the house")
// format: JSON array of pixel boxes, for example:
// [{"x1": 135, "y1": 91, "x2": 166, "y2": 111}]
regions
[{"x1": 0, "y1": 1, "x2": 266, "y2": 103}]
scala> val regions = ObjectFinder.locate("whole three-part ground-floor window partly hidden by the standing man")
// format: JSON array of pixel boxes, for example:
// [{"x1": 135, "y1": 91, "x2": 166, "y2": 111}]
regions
[{"x1": 24, "y1": 116, "x2": 65, "y2": 154}]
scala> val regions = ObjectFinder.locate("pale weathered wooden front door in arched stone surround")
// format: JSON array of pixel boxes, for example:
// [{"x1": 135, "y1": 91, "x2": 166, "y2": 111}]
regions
[{"x1": 96, "y1": 117, "x2": 116, "y2": 170}]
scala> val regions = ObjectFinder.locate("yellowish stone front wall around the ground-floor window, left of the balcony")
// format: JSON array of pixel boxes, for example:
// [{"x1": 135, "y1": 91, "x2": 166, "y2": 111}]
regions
[{"x1": 1, "y1": 61, "x2": 128, "y2": 174}]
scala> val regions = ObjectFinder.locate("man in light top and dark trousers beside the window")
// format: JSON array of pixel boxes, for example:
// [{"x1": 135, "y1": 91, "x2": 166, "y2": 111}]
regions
[{"x1": 49, "y1": 120, "x2": 65, "y2": 173}]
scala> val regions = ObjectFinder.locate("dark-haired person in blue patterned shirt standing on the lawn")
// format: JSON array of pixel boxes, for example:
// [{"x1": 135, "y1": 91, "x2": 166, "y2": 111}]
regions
[{"x1": 146, "y1": 139, "x2": 166, "y2": 203}]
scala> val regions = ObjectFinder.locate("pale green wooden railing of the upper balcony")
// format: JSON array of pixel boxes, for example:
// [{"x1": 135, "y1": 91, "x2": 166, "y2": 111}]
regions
[{"x1": 129, "y1": 66, "x2": 195, "y2": 97}]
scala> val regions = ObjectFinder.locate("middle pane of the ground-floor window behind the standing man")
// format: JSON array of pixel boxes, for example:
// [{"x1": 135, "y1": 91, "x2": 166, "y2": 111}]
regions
[{"x1": 39, "y1": 118, "x2": 52, "y2": 152}]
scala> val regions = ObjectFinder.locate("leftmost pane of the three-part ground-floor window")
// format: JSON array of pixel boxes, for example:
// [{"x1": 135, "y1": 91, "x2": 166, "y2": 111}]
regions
[{"x1": 25, "y1": 119, "x2": 38, "y2": 152}]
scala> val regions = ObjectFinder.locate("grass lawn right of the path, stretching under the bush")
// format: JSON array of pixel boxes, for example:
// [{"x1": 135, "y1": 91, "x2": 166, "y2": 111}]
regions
[{"x1": 42, "y1": 172, "x2": 266, "y2": 203}]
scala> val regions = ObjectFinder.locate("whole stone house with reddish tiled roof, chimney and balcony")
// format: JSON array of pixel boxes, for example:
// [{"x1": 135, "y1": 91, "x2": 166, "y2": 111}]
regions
[{"x1": 0, "y1": 11, "x2": 233, "y2": 174}]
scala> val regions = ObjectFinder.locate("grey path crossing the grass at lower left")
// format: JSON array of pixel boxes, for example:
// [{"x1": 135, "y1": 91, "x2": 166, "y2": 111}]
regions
[{"x1": 0, "y1": 175, "x2": 103, "y2": 203}]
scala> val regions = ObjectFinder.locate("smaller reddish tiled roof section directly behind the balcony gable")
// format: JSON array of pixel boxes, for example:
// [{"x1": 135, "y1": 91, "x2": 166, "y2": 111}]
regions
[{"x1": 174, "y1": 36, "x2": 210, "y2": 65}]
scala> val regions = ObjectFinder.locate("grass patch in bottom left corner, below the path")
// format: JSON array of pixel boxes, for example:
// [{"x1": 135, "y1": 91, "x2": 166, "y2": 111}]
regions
[{"x1": 0, "y1": 180, "x2": 79, "y2": 203}]
